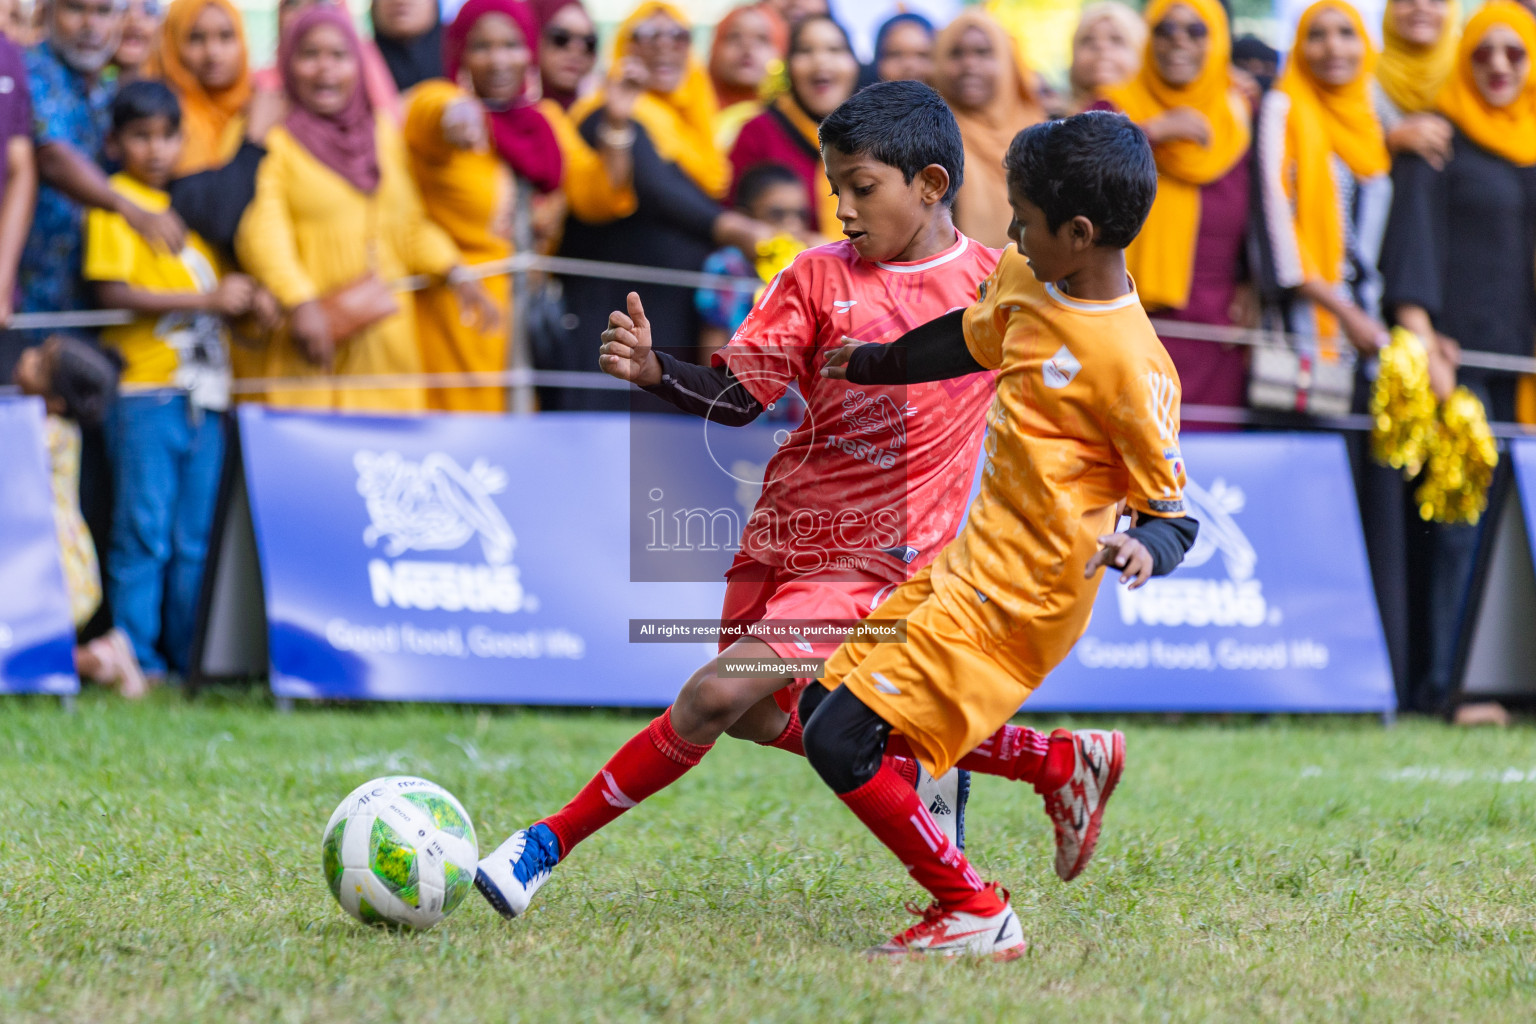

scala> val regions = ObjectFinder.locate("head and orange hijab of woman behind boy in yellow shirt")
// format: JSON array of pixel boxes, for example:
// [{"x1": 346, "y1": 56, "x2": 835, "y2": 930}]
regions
[{"x1": 160, "y1": 0, "x2": 250, "y2": 175}]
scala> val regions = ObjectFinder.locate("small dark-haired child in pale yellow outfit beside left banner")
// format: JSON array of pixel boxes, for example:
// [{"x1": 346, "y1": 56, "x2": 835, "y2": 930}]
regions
[{"x1": 14, "y1": 335, "x2": 147, "y2": 697}]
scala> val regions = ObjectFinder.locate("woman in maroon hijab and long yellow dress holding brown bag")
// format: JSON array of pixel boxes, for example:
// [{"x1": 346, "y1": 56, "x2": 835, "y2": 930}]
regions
[{"x1": 235, "y1": 5, "x2": 495, "y2": 411}]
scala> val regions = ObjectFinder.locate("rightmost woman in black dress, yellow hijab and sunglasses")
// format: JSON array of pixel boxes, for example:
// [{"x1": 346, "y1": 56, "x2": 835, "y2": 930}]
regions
[{"x1": 1381, "y1": 0, "x2": 1536, "y2": 711}]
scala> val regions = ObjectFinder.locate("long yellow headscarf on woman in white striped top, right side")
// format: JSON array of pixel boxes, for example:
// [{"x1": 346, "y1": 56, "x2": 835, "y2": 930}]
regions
[{"x1": 1278, "y1": 0, "x2": 1392, "y2": 313}]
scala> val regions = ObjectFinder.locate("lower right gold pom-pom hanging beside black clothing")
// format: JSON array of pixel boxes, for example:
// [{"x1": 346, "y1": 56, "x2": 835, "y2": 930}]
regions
[{"x1": 1413, "y1": 387, "x2": 1499, "y2": 524}]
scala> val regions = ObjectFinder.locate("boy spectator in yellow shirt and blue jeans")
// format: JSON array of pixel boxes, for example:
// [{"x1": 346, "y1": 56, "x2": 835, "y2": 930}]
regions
[{"x1": 83, "y1": 81, "x2": 275, "y2": 676}]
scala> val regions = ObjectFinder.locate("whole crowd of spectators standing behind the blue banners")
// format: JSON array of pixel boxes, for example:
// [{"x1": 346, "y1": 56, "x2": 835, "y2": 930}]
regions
[{"x1": 0, "y1": 0, "x2": 1536, "y2": 721}]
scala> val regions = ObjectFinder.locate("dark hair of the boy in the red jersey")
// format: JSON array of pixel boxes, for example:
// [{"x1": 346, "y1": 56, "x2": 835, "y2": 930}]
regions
[{"x1": 822, "y1": 81, "x2": 965, "y2": 206}]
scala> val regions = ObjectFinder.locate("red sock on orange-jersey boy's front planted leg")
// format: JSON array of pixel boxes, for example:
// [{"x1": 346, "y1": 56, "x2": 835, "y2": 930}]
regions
[{"x1": 839, "y1": 765, "x2": 1001, "y2": 913}]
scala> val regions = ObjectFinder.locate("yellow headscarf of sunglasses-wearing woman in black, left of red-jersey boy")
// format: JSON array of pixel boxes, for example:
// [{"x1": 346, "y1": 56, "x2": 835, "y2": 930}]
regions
[{"x1": 571, "y1": 0, "x2": 731, "y2": 198}]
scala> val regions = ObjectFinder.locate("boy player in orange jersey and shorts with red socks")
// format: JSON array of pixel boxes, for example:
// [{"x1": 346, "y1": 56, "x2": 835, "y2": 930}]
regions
[{"x1": 800, "y1": 112, "x2": 1198, "y2": 960}]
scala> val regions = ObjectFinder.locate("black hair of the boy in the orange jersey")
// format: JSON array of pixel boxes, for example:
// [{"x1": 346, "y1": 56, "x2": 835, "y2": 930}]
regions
[{"x1": 1003, "y1": 111, "x2": 1157, "y2": 249}]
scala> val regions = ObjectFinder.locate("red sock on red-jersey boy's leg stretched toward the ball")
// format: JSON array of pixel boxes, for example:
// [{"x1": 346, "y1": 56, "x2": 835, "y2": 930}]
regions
[{"x1": 542, "y1": 708, "x2": 714, "y2": 857}]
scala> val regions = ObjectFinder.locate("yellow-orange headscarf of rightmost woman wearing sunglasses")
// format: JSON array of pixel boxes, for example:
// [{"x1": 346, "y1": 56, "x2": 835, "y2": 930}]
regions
[{"x1": 1439, "y1": 0, "x2": 1536, "y2": 167}]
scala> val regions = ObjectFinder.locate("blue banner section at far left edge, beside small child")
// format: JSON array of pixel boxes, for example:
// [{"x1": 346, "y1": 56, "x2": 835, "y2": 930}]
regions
[{"x1": 0, "y1": 398, "x2": 80, "y2": 694}]
